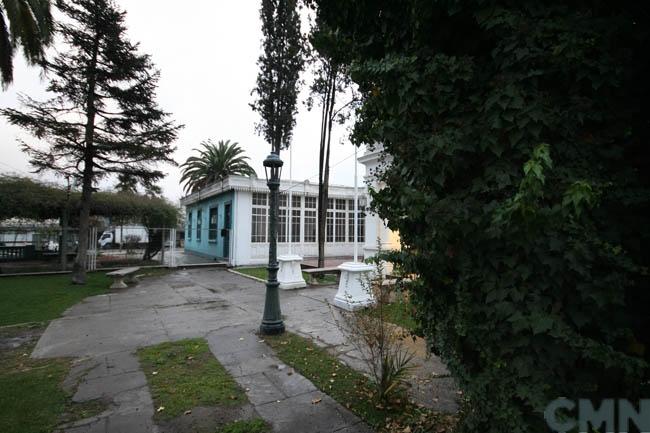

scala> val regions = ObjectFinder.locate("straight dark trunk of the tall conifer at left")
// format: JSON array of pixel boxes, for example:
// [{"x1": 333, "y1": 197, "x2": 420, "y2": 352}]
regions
[{"x1": 72, "y1": 37, "x2": 99, "y2": 284}]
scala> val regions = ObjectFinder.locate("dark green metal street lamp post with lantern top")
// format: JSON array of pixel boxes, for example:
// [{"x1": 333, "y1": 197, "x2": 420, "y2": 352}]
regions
[{"x1": 260, "y1": 152, "x2": 284, "y2": 335}]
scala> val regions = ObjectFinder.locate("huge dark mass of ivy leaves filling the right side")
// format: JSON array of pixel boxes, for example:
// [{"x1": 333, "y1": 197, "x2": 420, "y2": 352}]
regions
[{"x1": 308, "y1": 0, "x2": 650, "y2": 433}]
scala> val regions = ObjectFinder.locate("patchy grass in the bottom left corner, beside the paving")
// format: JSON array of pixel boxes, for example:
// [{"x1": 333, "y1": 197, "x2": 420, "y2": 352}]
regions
[{"x1": 0, "y1": 326, "x2": 105, "y2": 433}]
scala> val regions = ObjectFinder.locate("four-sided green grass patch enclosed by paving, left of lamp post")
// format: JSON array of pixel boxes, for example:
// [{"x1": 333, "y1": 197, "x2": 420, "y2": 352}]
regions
[{"x1": 138, "y1": 338, "x2": 246, "y2": 419}]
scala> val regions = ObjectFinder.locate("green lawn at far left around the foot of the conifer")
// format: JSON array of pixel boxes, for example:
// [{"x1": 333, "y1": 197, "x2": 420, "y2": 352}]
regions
[{"x1": 0, "y1": 272, "x2": 111, "y2": 326}]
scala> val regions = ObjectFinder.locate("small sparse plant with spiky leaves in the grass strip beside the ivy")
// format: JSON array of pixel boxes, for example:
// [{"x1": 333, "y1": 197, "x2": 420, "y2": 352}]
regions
[{"x1": 332, "y1": 245, "x2": 414, "y2": 403}]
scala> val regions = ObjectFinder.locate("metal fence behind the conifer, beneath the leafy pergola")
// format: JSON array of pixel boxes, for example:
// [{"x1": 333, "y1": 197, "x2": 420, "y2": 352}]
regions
[{"x1": 0, "y1": 224, "x2": 204, "y2": 275}]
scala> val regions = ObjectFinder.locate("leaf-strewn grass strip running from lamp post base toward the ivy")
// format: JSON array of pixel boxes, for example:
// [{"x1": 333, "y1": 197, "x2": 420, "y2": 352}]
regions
[{"x1": 264, "y1": 332, "x2": 455, "y2": 433}]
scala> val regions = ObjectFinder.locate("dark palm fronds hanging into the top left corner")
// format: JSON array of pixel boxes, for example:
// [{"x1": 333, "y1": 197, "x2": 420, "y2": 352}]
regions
[{"x1": 0, "y1": 0, "x2": 53, "y2": 87}]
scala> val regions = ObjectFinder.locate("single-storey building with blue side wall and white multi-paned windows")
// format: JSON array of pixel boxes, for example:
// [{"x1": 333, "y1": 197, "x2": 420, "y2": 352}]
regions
[{"x1": 181, "y1": 176, "x2": 366, "y2": 266}]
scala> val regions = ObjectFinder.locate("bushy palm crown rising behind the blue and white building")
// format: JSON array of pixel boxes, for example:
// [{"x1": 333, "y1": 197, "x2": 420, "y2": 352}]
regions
[{"x1": 181, "y1": 139, "x2": 257, "y2": 193}]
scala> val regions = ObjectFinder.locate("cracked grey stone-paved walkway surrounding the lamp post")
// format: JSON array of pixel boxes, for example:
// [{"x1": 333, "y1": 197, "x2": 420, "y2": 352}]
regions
[{"x1": 32, "y1": 268, "x2": 455, "y2": 433}]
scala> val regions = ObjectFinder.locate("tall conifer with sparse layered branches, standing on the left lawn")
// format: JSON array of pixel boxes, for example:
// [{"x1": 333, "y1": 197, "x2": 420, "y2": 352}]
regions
[{"x1": 1, "y1": 0, "x2": 182, "y2": 284}]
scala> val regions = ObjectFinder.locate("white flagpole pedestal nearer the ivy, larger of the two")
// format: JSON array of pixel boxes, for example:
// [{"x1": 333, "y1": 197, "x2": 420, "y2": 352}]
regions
[{"x1": 333, "y1": 262, "x2": 375, "y2": 311}]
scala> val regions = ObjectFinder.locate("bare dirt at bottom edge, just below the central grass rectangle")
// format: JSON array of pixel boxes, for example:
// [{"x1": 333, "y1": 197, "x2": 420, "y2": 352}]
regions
[{"x1": 157, "y1": 404, "x2": 257, "y2": 433}]
